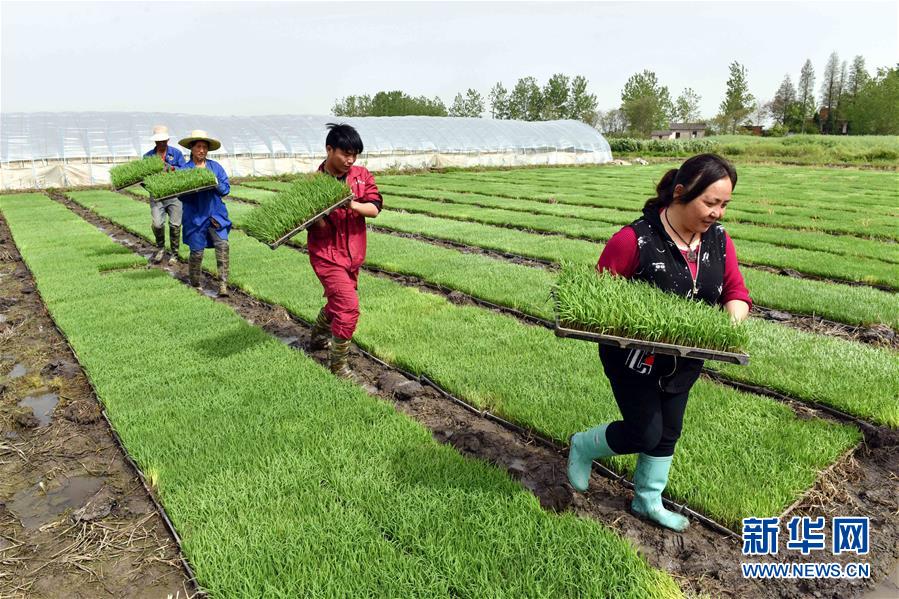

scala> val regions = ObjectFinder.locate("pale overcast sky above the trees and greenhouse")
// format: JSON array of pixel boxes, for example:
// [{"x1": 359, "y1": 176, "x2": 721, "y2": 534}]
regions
[{"x1": 0, "y1": 1, "x2": 899, "y2": 117}]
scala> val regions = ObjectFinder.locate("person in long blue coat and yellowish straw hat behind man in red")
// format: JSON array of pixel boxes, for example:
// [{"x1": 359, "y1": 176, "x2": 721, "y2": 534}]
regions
[{"x1": 178, "y1": 129, "x2": 231, "y2": 295}]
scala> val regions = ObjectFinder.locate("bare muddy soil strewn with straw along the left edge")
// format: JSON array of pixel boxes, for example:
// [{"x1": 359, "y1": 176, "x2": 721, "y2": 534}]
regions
[{"x1": 0, "y1": 218, "x2": 195, "y2": 599}]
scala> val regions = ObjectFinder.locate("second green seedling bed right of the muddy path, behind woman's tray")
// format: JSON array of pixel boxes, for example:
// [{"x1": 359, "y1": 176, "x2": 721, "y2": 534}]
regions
[{"x1": 179, "y1": 193, "x2": 899, "y2": 426}]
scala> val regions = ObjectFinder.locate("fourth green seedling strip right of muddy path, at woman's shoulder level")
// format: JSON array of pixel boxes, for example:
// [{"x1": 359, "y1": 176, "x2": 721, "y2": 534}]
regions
[{"x1": 388, "y1": 196, "x2": 899, "y2": 289}]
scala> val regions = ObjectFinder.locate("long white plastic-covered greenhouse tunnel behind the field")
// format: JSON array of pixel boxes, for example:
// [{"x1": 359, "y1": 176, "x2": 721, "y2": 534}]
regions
[{"x1": 0, "y1": 112, "x2": 612, "y2": 189}]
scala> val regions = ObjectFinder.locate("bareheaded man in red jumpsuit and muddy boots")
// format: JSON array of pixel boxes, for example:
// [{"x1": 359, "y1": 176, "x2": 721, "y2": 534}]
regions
[{"x1": 307, "y1": 123, "x2": 384, "y2": 378}]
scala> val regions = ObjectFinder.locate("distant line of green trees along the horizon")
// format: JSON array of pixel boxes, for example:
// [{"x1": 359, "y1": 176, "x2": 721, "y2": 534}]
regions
[{"x1": 332, "y1": 52, "x2": 899, "y2": 138}]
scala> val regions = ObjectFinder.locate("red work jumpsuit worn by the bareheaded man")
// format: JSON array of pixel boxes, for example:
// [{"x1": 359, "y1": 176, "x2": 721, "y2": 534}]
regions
[{"x1": 307, "y1": 162, "x2": 384, "y2": 339}]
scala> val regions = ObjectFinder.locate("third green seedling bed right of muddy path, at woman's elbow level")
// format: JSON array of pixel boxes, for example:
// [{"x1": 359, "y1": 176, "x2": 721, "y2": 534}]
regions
[{"x1": 375, "y1": 210, "x2": 899, "y2": 329}]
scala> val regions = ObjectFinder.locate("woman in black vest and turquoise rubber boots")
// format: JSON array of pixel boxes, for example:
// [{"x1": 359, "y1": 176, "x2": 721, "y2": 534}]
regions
[{"x1": 568, "y1": 154, "x2": 752, "y2": 531}]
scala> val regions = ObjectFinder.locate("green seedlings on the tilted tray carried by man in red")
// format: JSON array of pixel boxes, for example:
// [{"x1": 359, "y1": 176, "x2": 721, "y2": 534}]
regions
[{"x1": 244, "y1": 173, "x2": 352, "y2": 243}]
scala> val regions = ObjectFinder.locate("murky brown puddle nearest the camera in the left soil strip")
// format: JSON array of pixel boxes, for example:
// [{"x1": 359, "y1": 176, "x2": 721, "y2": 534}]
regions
[{"x1": 6, "y1": 476, "x2": 103, "y2": 530}]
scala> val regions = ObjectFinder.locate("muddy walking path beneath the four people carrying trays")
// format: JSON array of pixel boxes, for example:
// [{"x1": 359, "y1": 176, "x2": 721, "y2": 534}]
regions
[{"x1": 56, "y1": 195, "x2": 899, "y2": 598}]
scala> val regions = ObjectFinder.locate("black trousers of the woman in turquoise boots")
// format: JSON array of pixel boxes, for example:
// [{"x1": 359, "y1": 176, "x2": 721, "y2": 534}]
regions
[{"x1": 600, "y1": 348, "x2": 698, "y2": 457}]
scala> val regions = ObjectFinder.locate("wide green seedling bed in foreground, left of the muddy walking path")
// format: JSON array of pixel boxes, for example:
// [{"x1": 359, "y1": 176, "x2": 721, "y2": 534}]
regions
[{"x1": 2, "y1": 196, "x2": 680, "y2": 598}]
